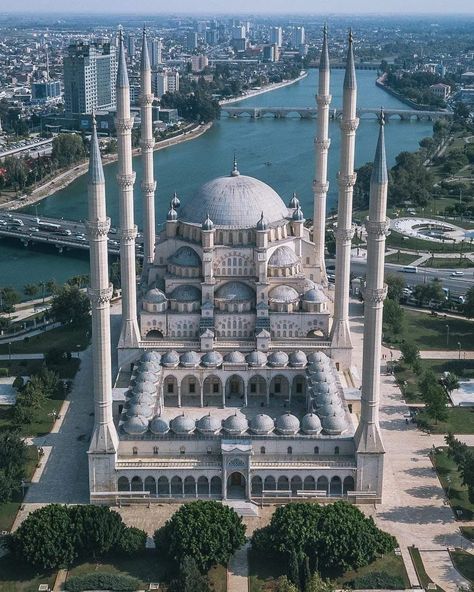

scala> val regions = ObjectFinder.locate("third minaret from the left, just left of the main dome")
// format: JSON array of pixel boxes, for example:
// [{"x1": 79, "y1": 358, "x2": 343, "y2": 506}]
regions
[{"x1": 140, "y1": 28, "x2": 156, "y2": 265}]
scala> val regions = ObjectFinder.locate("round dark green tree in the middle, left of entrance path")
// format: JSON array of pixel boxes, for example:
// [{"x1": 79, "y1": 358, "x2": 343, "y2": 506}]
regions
[{"x1": 154, "y1": 500, "x2": 245, "y2": 573}]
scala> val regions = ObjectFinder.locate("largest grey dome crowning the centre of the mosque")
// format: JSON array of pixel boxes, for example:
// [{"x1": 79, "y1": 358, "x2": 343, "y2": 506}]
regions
[{"x1": 180, "y1": 174, "x2": 288, "y2": 228}]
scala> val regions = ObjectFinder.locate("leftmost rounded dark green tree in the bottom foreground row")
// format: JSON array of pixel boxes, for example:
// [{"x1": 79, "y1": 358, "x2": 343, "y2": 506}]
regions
[{"x1": 10, "y1": 504, "x2": 77, "y2": 569}]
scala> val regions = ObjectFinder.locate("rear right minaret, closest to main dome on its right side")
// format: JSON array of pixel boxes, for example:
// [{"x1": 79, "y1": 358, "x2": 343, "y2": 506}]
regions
[{"x1": 313, "y1": 25, "x2": 331, "y2": 285}]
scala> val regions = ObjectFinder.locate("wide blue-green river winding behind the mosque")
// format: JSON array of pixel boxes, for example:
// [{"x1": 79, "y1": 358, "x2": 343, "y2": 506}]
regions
[{"x1": 0, "y1": 70, "x2": 432, "y2": 288}]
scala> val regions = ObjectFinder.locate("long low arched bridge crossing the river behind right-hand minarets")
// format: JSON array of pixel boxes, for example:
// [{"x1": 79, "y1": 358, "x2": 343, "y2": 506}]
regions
[{"x1": 221, "y1": 107, "x2": 453, "y2": 121}]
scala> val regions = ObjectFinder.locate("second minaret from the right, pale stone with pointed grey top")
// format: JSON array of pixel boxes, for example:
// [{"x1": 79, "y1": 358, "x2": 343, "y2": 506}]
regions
[{"x1": 331, "y1": 31, "x2": 359, "y2": 368}]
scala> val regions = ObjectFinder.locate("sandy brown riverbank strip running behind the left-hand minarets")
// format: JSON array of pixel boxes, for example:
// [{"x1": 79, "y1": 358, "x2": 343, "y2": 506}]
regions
[{"x1": 0, "y1": 122, "x2": 212, "y2": 211}]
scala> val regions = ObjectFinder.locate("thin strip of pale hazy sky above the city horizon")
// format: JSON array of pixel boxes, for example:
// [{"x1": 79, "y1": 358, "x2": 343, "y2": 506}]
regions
[{"x1": 2, "y1": 0, "x2": 474, "y2": 16}]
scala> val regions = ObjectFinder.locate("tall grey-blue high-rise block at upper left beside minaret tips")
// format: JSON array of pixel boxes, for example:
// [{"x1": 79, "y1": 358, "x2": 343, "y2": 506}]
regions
[{"x1": 63, "y1": 41, "x2": 117, "y2": 114}]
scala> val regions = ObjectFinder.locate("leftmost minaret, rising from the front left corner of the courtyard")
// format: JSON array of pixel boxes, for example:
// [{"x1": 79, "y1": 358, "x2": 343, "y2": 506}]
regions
[{"x1": 86, "y1": 119, "x2": 118, "y2": 492}]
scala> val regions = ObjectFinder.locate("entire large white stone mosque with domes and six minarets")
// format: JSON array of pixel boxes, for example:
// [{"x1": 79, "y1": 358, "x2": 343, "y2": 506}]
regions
[{"x1": 87, "y1": 30, "x2": 388, "y2": 503}]
